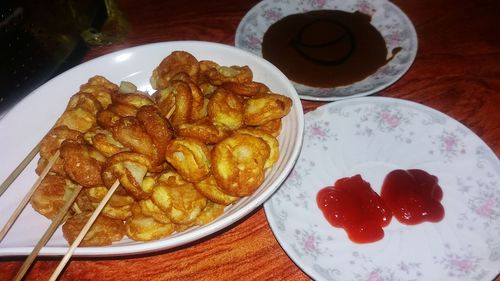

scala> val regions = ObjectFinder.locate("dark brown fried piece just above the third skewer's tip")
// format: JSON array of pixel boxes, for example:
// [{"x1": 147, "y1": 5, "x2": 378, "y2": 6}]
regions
[{"x1": 61, "y1": 141, "x2": 105, "y2": 187}]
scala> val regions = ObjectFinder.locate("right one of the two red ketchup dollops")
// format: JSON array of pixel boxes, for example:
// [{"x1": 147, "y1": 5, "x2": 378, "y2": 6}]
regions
[{"x1": 380, "y1": 169, "x2": 444, "y2": 225}]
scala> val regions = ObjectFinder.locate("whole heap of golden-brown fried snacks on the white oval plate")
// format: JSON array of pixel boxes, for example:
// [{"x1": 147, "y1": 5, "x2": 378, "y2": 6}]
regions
[{"x1": 31, "y1": 51, "x2": 292, "y2": 246}]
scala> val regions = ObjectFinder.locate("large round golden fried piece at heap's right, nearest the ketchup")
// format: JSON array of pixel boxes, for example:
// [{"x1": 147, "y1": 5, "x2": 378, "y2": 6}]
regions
[{"x1": 211, "y1": 134, "x2": 270, "y2": 197}]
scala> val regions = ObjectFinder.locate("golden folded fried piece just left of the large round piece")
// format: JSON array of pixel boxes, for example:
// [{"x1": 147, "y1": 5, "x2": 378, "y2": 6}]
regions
[{"x1": 165, "y1": 138, "x2": 210, "y2": 182}]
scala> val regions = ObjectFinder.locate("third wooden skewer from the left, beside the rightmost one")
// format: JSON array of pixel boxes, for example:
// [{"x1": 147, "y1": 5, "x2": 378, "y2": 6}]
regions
[{"x1": 13, "y1": 185, "x2": 82, "y2": 281}]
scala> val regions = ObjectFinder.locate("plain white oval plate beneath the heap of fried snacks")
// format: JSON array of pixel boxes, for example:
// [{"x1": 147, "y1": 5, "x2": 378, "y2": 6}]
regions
[{"x1": 0, "y1": 41, "x2": 304, "y2": 256}]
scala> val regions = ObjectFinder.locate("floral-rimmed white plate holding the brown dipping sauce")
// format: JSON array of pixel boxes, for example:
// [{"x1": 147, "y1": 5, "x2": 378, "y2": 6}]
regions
[{"x1": 235, "y1": 0, "x2": 417, "y2": 101}]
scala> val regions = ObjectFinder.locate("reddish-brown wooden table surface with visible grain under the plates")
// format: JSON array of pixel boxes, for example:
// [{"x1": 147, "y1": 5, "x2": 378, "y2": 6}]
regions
[{"x1": 0, "y1": 0, "x2": 500, "y2": 281}]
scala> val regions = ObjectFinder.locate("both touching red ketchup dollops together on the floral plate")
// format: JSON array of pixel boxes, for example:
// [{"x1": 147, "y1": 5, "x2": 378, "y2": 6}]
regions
[{"x1": 316, "y1": 169, "x2": 444, "y2": 243}]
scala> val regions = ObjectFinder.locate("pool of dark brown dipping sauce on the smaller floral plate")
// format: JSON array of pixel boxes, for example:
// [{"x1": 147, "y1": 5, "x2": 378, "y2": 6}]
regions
[{"x1": 262, "y1": 10, "x2": 399, "y2": 87}]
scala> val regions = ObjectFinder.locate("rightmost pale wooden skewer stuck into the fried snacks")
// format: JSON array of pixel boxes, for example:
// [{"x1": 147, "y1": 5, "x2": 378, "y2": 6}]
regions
[{"x1": 49, "y1": 180, "x2": 120, "y2": 281}]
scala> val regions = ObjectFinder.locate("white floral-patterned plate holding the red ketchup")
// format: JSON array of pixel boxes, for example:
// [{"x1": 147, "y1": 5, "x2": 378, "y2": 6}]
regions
[{"x1": 264, "y1": 97, "x2": 500, "y2": 281}]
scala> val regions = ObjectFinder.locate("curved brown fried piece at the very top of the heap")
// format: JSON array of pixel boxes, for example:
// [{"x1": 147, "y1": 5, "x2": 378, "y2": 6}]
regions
[{"x1": 150, "y1": 51, "x2": 200, "y2": 90}]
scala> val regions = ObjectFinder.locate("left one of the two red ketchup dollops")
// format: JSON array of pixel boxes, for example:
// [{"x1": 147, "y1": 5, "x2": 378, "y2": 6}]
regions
[{"x1": 316, "y1": 175, "x2": 392, "y2": 243}]
